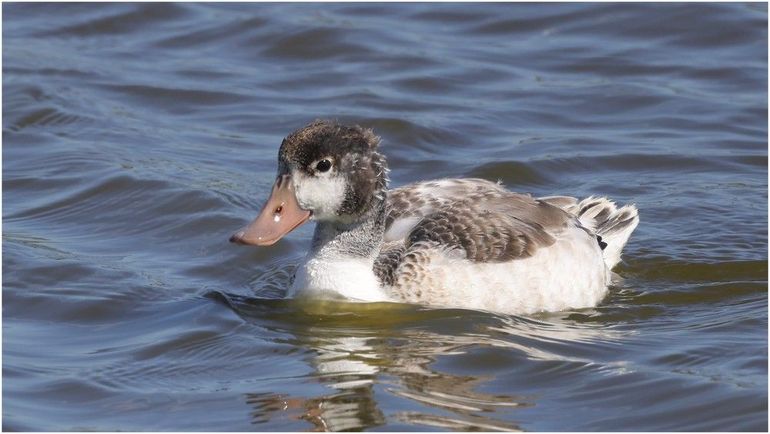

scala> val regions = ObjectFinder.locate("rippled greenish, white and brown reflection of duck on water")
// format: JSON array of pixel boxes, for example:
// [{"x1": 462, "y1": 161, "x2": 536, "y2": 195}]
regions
[{"x1": 217, "y1": 294, "x2": 614, "y2": 431}]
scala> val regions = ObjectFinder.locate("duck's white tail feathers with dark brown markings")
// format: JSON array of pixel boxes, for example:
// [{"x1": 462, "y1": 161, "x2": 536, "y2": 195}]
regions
[{"x1": 541, "y1": 196, "x2": 639, "y2": 270}]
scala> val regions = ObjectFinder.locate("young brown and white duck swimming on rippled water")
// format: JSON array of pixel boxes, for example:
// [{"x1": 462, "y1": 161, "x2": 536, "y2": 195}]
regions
[{"x1": 230, "y1": 120, "x2": 639, "y2": 314}]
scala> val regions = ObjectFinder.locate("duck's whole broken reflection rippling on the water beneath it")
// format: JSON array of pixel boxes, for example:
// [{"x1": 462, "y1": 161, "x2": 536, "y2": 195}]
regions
[{"x1": 219, "y1": 294, "x2": 620, "y2": 431}]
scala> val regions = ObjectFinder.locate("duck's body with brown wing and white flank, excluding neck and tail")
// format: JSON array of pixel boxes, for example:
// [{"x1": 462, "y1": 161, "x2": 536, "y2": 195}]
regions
[{"x1": 375, "y1": 179, "x2": 636, "y2": 313}]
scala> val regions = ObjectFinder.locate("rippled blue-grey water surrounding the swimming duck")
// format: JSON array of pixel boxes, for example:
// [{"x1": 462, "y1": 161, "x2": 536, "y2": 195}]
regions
[{"x1": 2, "y1": 3, "x2": 768, "y2": 431}]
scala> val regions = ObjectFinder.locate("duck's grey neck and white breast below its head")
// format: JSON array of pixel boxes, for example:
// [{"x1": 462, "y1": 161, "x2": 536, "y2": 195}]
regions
[{"x1": 287, "y1": 197, "x2": 390, "y2": 301}]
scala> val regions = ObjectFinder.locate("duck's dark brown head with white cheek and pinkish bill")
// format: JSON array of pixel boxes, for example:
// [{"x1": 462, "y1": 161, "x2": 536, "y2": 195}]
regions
[{"x1": 230, "y1": 121, "x2": 387, "y2": 246}]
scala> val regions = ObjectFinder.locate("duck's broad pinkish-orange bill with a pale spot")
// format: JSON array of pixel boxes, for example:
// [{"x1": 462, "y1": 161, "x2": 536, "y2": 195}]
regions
[{"x1": 230, "y1": 175, "x2": 311, "y2": 246}]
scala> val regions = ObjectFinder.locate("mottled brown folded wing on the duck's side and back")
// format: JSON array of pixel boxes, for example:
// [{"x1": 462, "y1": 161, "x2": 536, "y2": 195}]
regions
[{"x1": 386, "y1": 179, "x2": 572, "y2": 262}]
